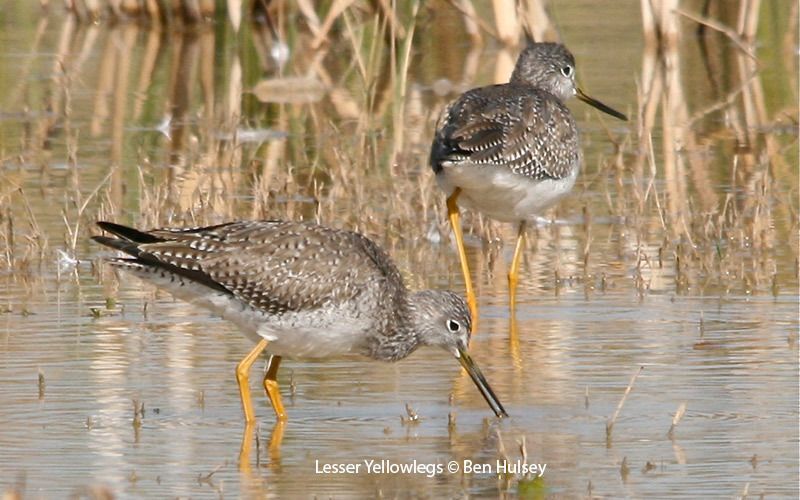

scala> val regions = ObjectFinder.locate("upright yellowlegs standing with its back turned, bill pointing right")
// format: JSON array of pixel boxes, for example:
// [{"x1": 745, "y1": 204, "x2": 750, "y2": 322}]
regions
[{"x1": 430, "y1": 42, "x2": 627, "y2": 318}]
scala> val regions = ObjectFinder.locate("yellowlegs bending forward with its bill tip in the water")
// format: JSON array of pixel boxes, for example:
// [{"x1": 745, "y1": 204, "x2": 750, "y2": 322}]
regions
[{"x1": 92, "y1": 221, "x2": 506, "y2": 423}]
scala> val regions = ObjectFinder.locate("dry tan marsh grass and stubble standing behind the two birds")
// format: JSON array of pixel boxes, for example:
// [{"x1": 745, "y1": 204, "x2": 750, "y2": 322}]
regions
[{"x1": 0, "y1": 2, "x2": 798, "y2": 304}]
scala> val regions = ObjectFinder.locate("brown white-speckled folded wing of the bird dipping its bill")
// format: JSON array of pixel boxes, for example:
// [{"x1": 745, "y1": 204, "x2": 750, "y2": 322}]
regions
[{"x1": 96, "y1": 221, "x2": 402, "y2": 314}]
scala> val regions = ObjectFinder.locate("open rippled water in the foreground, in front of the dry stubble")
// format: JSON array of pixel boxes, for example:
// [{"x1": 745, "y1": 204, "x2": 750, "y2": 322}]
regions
[{"x1": 0, "y1": 284, "x2": 797, "y2": 497}]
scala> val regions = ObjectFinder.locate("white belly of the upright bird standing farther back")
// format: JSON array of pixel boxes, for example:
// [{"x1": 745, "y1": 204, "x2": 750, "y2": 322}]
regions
[{"x1": 436, "y1": 164, "x2": 578, "y2": 222}]
